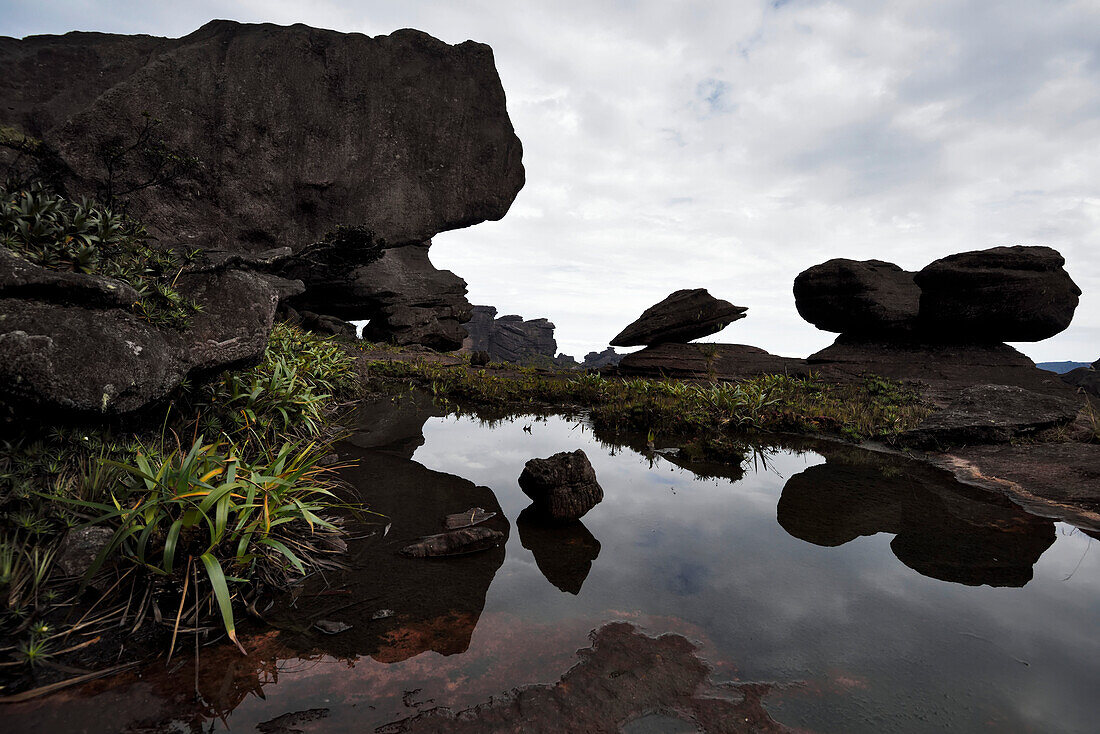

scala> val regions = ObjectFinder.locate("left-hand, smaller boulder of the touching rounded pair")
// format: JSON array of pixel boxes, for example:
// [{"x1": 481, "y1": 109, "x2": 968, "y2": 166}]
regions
[{"x1": 794, "y1": 258, "x2": 921, "y2": 335}]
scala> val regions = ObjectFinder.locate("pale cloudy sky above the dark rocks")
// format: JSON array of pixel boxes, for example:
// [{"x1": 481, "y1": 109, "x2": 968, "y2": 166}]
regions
[{"x1": 0, "y1": 0, "x2": 1100, "y2": 361}]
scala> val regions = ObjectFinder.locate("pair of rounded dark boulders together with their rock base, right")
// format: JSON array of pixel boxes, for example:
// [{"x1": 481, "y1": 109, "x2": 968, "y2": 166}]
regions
[{"x1": 794, "y1": 247, "x2": 1080, "y2": 393}]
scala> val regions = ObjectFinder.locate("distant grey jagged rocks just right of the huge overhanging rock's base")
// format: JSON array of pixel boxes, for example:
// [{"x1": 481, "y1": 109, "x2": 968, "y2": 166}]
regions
[{"x1": 463, "y1": 306, "x2": 558, "y2": 366}]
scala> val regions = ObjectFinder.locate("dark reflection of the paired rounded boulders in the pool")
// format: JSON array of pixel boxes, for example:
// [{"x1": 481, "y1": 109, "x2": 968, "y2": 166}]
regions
[{"x1": 777, "y1": 460, "x2": 1055, "y2": 587}]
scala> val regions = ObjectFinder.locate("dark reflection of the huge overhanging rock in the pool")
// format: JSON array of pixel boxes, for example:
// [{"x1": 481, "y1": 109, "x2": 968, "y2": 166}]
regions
[{"x1": 274, "y1": 393, "x2": 509, "y2": 662}]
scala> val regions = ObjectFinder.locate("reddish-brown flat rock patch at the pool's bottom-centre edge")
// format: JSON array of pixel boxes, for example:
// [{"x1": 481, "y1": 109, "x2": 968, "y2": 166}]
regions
[{"x1": 375, "y1": 622, "x2": 791, "y2": 734}]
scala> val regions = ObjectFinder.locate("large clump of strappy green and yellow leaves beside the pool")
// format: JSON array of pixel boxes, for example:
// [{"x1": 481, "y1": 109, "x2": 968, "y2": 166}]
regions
[{"x1": 0, "y1": 325, "x2": 359, "y2": 662}]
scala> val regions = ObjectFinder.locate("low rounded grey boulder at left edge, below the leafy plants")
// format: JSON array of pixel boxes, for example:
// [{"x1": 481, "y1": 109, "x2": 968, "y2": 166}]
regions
[{"x1": 0, "y1": 249, "x2": 278, "y2": 418}]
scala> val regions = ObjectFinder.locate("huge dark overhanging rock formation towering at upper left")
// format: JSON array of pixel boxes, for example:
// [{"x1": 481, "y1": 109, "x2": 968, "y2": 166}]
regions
[{"x1": 0, "y1": 21, "x2": 524, "y2": 348}]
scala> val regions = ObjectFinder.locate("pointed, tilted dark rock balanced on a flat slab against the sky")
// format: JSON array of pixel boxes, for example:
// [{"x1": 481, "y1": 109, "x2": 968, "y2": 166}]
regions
[{"x1": 611, "y1": 288, "x2": 748, "y2": 347}]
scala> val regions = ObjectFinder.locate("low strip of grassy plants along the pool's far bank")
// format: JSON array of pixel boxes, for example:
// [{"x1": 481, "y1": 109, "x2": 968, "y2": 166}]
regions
[{"x1": 367, "y1": 361, "x2": 931, "y2": 440}]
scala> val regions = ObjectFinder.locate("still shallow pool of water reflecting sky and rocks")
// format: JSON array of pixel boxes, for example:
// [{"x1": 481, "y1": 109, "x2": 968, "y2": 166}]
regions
[{"x1": 0, "y1": 397, "x2": 1100, "y2": 732}]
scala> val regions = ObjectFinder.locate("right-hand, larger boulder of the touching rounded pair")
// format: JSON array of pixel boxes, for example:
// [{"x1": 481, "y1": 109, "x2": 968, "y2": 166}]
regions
[{"x1": 915, "y1": 245, "x2": 1081, "y2": 342}]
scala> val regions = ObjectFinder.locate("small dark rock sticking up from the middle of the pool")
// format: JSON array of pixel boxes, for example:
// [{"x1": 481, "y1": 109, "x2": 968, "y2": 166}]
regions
[{"x1": 519, "y1": 449, "x2": 604, "y2": 519}]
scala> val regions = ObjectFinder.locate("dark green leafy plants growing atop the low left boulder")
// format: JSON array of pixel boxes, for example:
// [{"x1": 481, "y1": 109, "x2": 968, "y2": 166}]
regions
[{"x1": 0, "y1": 183, "x2": 200, "y2": 328}]
